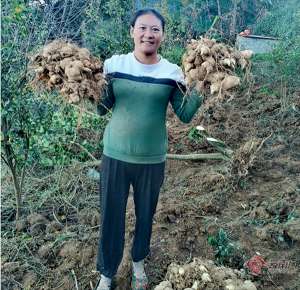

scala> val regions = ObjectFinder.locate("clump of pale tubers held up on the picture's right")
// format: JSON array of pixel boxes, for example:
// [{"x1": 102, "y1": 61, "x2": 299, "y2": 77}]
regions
[{"x1": 182, "y1": 38, "x2": 252, "y2": 101}]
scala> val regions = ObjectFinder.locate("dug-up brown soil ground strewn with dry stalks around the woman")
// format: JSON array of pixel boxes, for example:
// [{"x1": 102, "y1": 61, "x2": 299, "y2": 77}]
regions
[{"x1": 1, "y1": 73, "x2": 300, "y2": 290}]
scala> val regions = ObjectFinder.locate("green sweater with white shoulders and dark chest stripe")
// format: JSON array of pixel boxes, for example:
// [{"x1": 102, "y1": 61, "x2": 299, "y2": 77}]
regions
[{"x1": 98, "y1": 53, "x2": 201, "y2": 164}]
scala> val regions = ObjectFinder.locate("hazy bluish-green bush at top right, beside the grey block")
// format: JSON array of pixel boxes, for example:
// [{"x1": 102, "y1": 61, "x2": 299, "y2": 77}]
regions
[{"x1": 254, "y1": 0, "x2": 300, "y2": 91}]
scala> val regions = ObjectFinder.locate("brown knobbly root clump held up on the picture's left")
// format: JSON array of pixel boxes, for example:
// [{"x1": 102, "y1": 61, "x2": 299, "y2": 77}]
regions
[{"x1": 30, "y1": 40, "x2": 106, "y2": 103}]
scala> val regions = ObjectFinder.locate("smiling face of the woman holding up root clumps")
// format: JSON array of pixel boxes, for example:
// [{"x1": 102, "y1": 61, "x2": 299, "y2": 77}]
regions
[{"x1": 130, "y1": 14, "x2": 163, "y2": 55}]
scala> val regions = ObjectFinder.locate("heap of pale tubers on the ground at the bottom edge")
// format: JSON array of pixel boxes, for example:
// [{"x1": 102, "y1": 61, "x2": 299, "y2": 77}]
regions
[{"x1": 154, "y1": 258, "x2": 257, "y2": 290}]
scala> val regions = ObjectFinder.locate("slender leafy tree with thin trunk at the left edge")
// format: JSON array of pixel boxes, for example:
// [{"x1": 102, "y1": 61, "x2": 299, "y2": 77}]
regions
[{"x1": 1, "y1": 1, "x2": 49, "y2": 219}]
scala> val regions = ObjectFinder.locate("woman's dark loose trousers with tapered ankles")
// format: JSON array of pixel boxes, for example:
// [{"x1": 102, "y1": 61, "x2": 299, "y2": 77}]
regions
[{"x1": 97, "y1": 155, "x2": 165, "y2": 278}]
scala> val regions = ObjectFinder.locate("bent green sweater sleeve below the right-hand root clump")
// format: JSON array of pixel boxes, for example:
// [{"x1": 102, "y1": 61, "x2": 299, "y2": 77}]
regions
[{"x1": 170, "y1": 85, "x2": 202, "y2": 123}]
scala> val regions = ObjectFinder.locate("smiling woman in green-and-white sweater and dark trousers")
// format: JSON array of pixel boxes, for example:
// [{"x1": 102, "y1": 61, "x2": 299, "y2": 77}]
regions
[{"x1": 96, "y1": 9, "x2": 201, "y2": 290}]
